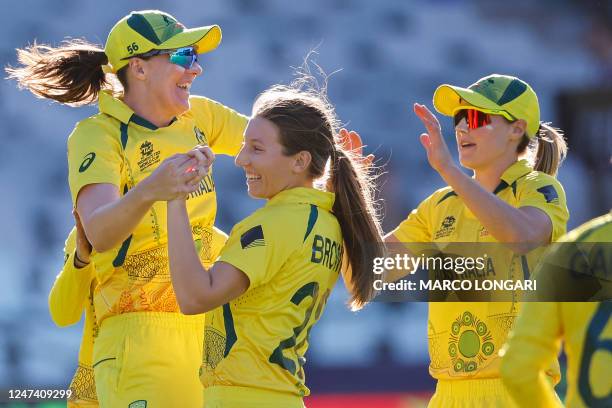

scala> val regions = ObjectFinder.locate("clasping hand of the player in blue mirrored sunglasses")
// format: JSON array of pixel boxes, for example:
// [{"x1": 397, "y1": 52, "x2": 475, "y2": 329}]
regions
[{"x1": 140, "y1": 154, "x2": 206, "y2": 202}]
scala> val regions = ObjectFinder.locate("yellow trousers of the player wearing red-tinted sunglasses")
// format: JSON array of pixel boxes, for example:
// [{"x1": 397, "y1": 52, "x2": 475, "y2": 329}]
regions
[{"x1": 428, "y1": 378, "x2": 516, "y2": 408}]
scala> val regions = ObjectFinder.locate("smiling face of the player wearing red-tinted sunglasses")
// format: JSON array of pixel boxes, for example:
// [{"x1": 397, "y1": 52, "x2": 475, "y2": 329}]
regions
[{"x1": 455, "y1": 115, "x2": 524, "y2": 170}]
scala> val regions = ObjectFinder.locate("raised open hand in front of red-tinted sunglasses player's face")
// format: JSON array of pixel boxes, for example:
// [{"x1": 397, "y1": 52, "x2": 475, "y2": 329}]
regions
[{"x1": 414, "y1": 103, "x2": 455, "y2": 175}]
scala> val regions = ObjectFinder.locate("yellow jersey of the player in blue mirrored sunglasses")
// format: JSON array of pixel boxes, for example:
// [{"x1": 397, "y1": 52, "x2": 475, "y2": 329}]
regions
[{"x1": 68, "y1": 92, "x2": 247, "y2": 322}]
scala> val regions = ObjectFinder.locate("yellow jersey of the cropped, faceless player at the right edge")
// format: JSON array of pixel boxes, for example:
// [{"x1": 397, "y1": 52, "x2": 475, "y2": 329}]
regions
[{"x1": 502, "y1": 213, "x2": 612, "y2": 407}]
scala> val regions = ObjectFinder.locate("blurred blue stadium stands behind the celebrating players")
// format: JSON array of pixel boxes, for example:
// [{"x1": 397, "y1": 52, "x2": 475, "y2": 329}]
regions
[{"x1": 0, "y1": 0, "x2": 612, "y2": 408}]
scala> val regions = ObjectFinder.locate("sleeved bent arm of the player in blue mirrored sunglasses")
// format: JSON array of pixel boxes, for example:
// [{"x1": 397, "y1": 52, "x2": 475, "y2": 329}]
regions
[{"x1": 68, "y1": 121, "x2": 205, "y2": 252}]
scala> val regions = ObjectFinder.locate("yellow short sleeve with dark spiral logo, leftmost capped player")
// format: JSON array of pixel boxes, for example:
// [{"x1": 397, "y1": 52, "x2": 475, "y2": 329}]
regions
[{"x1": 68, "y1": 121, "x2": 123, "y2": 205}]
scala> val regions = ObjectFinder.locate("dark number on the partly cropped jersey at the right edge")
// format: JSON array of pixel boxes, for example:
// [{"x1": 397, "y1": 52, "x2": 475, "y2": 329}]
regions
[{"x1": 578, "y1": 302, "x2": 612, "y2": 407}]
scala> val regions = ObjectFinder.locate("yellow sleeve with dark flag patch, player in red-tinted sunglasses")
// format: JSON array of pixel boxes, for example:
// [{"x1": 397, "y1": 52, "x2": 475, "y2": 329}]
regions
[{"x1": 517, "y1": 172, "x2": 569, "y2": 242}]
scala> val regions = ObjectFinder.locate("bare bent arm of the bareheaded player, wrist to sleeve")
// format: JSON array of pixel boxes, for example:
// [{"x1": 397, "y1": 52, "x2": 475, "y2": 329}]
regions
[{"x1": 168, "y1": 200, "x2": 250, "y2": 314}]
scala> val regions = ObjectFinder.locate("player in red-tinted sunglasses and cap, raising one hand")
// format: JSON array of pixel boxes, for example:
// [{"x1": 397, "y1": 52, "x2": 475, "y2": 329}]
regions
[{"x1": 386, "y1": 74, "x2": 568, "y2": 407}]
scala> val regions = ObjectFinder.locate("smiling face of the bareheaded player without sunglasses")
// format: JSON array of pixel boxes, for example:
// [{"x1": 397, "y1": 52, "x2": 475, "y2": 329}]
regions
[{"x1": 236, "y1": 116, "x2": 304, "y2": 199}]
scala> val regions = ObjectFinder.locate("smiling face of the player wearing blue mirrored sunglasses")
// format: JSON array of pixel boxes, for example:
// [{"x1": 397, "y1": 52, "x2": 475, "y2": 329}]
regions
[{"x1": 139, "y1": 55, "x2": 202, "y2": 117}]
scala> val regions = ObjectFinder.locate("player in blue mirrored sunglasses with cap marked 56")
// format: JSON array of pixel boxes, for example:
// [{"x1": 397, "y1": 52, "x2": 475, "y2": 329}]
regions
[{"x1": 8, "y1": 10, "x2": 246, "y2": 407}]
